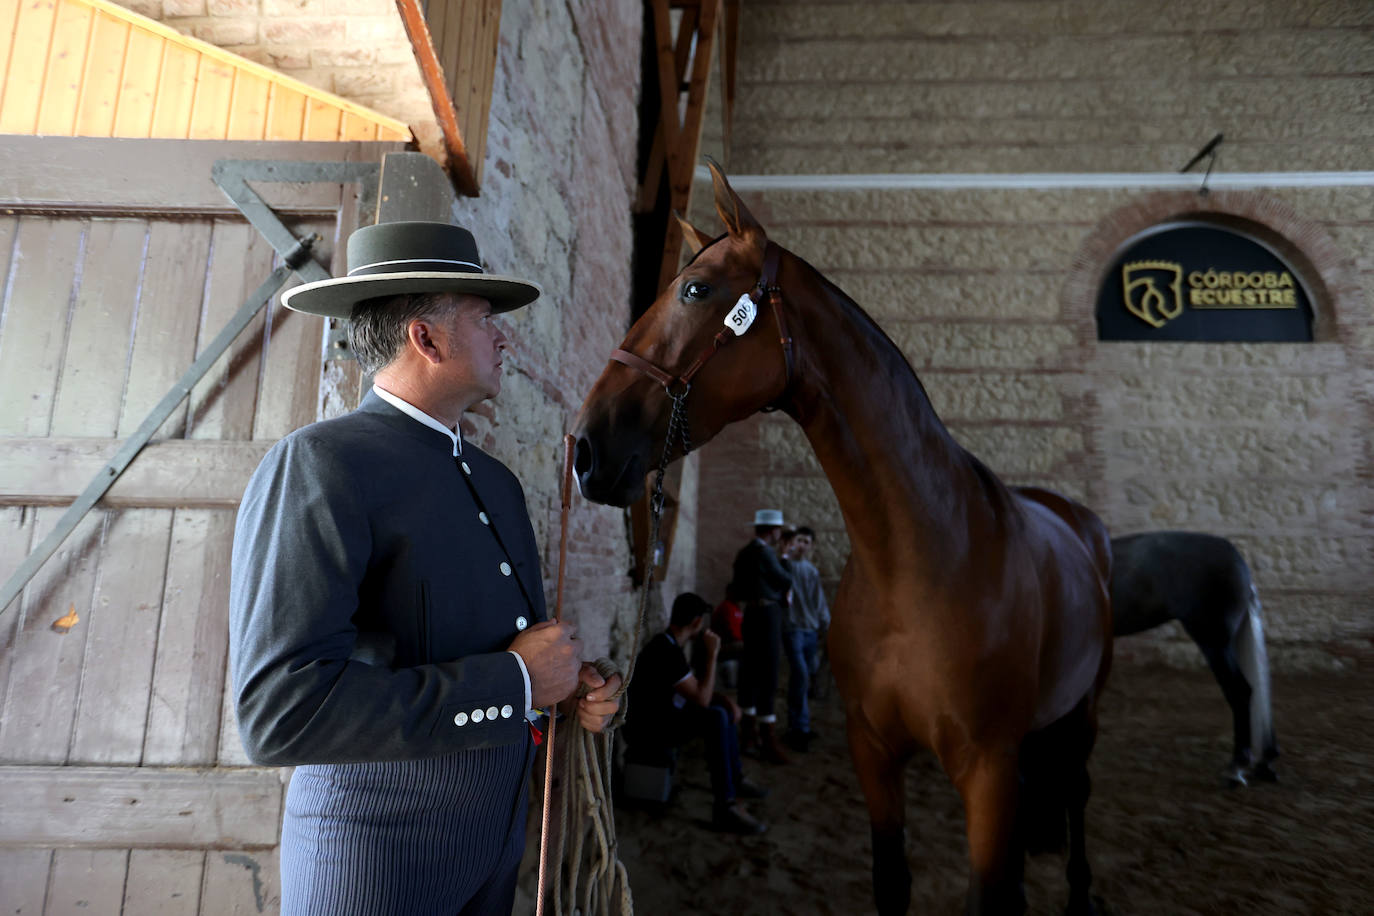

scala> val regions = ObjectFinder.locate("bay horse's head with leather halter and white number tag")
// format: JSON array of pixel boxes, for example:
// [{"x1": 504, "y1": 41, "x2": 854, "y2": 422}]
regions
[{"x1": 573, "y1": 162, "x2": 790, "y2": 505}]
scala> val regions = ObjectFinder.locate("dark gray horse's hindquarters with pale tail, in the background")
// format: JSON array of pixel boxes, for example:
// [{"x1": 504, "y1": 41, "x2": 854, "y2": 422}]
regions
[{"x1": 1112, "y1": 531, "x2": 1279, "y2": 786}]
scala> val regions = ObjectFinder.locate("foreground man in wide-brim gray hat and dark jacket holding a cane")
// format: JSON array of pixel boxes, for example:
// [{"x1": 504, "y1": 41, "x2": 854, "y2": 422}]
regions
[{"x1": 229, "y1": 222, "x2": 618, "y2": 916}]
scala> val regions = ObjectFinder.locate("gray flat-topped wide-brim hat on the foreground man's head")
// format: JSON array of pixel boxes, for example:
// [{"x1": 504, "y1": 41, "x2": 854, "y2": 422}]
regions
[{"x1": 282, "y1": 221, "x2": 543, "y2": 319}]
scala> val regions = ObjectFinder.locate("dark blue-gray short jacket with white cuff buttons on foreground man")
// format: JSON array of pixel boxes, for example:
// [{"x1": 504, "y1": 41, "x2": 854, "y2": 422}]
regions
[{"x1": 229, "y1": 393, "x2": 545, "y2": 776}]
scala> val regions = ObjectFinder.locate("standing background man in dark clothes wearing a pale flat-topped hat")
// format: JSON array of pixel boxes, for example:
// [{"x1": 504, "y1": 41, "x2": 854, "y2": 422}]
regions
[{"x1": 730, "y1": 509, "x2": 791, "y2": 764}]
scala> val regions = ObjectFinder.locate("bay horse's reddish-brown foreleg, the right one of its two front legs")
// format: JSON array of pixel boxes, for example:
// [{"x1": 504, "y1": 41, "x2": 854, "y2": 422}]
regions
[{"x1": 955, "y1": 747, "x2": 1026, "y2": 915}]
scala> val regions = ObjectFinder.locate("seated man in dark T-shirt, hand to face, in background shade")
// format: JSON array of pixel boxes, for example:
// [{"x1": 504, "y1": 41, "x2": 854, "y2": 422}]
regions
[{"x1": 624, "y1": 592, "x2": 768, "y2": 834}]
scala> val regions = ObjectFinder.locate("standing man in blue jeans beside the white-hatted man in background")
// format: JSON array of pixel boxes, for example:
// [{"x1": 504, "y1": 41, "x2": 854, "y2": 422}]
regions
[{"x1": 782, "y1": 525, "x2": 830, "y2": 753}]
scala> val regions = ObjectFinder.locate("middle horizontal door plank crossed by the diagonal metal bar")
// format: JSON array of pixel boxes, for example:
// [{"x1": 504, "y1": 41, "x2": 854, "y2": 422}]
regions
[{"x1": 0, "y1": 437, "x2": 272, "y2": 508}]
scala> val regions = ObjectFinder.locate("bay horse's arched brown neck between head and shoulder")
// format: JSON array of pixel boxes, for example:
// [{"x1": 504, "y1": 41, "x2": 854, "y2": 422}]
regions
[{"x1": 783, "y1": 275, "x2": 1006, "y2": 570}]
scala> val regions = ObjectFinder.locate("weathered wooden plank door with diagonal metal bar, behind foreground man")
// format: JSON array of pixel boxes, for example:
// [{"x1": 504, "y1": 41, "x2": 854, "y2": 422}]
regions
[{"x1": 0, "y1": 139, "x2": 395, "y2": 915}]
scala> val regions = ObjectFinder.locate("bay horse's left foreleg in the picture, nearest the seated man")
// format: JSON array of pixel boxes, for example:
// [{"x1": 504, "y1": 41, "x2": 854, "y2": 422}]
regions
[{"x1": 849, "y1": 715, "x2": 911, "y2": 916}]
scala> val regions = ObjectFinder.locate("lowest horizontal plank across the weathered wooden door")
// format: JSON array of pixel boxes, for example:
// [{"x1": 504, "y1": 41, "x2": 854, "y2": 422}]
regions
[{"x1": 0, "y1": 766, "x2": 283, "y2": 849}]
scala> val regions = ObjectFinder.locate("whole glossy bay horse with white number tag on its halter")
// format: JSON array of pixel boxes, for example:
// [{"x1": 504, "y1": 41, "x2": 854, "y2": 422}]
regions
[{"x1": 574, "y1": 162, "x2": 1112, "y2": 915}]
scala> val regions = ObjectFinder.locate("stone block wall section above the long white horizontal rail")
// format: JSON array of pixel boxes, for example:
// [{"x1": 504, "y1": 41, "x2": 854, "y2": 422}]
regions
[{"x1": 708, "y1": 0, "x2": 1374, "y2": 174}]
